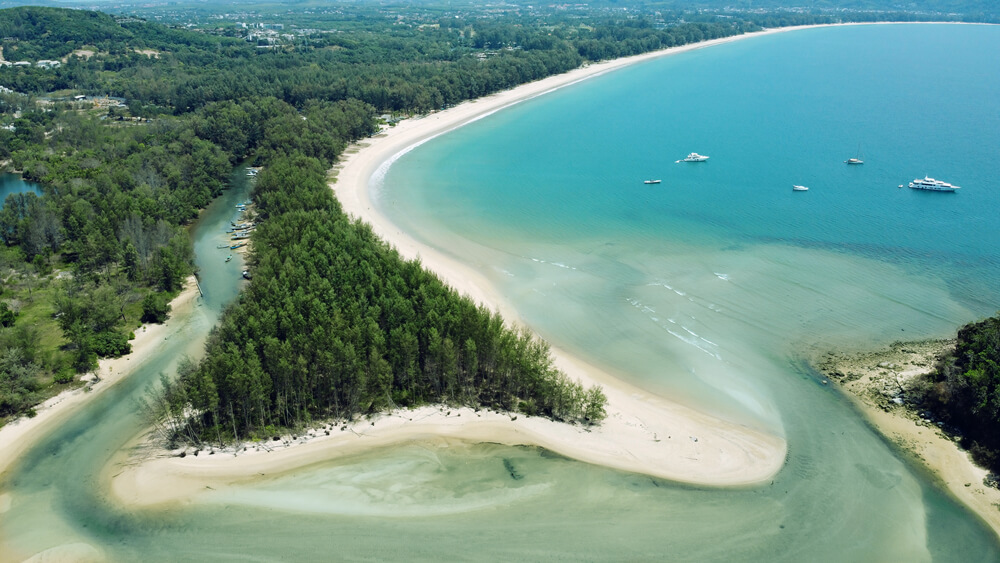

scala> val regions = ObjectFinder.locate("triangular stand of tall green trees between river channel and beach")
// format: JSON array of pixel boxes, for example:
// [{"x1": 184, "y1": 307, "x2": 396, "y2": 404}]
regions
[{"x1": 166, "y1": 151, "x2": 606, "y2": 441}]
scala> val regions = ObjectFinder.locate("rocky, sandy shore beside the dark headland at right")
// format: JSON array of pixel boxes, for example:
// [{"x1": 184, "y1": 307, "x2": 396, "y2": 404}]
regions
[{"x1": 814, "y1": 340, "x2": 1000, "y2": 536}]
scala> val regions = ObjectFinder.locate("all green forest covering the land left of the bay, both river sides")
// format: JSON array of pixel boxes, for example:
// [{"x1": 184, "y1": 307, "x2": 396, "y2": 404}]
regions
[{"x1": 0, "y1": 0, "x2": 992, "y2": 437}]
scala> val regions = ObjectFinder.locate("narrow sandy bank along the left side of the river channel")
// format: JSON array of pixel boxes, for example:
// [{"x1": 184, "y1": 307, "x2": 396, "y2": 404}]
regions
[{"x1": 0, "y1": 277, "x2": 199, "y2": 482}]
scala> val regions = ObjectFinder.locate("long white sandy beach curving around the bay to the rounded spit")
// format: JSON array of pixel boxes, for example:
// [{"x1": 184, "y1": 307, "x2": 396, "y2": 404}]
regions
[{"x1": 105, "y1": 28, "x2": 820, "y2": 506}]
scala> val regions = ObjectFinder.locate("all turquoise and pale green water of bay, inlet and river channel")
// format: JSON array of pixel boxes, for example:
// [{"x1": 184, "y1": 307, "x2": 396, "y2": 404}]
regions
[{"x1": 0, "y1": 25, "x2": 1000, "y2": 562}]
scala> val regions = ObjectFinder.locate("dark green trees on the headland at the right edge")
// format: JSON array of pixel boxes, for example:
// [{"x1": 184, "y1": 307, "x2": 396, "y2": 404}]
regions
[{"x1": 923, "y1": 316, "x2": 1000, "y2": 473}]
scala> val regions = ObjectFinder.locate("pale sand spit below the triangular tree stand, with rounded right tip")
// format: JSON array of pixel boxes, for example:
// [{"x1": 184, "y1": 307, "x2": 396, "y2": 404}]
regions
[{"x1": 104, "y1": 356, "x2": 786, "y2": 507}]
